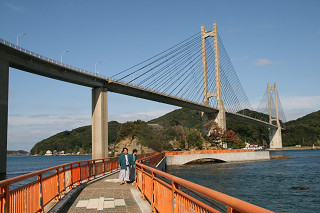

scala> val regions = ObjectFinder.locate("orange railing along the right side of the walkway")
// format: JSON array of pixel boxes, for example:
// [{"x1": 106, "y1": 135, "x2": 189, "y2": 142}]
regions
[{"x1": 136, "y1": 153, "x2": 271, "y2": 213}]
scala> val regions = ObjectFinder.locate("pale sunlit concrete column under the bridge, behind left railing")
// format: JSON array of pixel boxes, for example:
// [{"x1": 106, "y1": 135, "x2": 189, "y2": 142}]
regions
[{"x1": 92, "y1": 87, "x2": 108, "y2": 159}]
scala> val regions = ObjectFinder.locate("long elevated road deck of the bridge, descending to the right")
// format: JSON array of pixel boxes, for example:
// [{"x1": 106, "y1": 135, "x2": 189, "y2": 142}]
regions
[{"x1": 0, "y1": 40, "x2": 277, "y2": 129}]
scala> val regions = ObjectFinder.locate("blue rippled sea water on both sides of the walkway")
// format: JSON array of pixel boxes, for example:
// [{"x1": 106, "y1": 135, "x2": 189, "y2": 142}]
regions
[{"x1": 6, "y1": 150, "x2": 320, "y2": 212}]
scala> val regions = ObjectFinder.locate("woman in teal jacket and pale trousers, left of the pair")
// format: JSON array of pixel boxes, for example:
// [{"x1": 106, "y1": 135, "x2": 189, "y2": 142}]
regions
[{"x1": 118, "y1": 147, "x2": 133, "y2": 185}]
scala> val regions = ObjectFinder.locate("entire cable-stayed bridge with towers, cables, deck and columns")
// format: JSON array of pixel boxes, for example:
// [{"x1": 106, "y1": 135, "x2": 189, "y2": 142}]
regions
[{"x1": 0, "y1": 24, "x2": 284, "y2": 173}]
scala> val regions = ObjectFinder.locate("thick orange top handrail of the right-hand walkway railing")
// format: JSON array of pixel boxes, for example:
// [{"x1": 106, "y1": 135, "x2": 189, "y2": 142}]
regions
[{"x1": 136, "y1": 151, "x2": 272, "y2": 213}]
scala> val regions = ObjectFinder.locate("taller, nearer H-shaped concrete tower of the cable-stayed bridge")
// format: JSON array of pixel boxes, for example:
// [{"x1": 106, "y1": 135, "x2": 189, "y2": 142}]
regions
[{"x1": 201, "y1": 23, "x2": 227, "y2": 131}]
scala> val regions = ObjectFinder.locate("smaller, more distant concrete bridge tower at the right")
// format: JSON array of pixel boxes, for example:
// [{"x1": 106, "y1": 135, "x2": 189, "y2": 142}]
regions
[{"x1": 268, "y1": 83, "x2": 282, "y2": 149}]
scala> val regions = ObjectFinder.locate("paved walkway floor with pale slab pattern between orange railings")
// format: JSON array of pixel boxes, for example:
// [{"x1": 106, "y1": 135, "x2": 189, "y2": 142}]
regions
[{"x1": 68, "y1": 173, "x2": 151, "y2": 213}]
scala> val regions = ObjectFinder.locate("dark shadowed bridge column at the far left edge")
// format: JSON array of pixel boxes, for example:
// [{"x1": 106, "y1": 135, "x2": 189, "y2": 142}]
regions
[{"x1": 0, "y1": 61, "x2": 9, "y2": 175}]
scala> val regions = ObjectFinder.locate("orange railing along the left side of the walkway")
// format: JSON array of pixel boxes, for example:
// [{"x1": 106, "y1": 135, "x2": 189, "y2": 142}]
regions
[{"x1": 0, "y1": 153, "x2": 154, "y2": 213}]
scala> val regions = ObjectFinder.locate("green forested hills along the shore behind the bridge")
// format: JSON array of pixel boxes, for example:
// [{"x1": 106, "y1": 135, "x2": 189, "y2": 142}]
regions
[{"x1": 31, "y1": 108, "x2": 320, "y2": 154}]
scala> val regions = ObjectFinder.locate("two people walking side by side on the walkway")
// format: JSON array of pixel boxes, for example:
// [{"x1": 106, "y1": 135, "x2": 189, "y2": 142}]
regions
[{"x1": 118, "y1": 148, "x2": 139, "y2": 185}]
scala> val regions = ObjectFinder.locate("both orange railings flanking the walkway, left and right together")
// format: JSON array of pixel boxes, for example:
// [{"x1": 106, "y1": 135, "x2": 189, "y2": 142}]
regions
[{"x1": 0, "y1": 152, "x2": 271, "y2": 213}]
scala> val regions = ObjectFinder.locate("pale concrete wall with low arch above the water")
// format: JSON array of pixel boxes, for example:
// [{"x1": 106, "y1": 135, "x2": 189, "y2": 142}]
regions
[{"x1": 166, "y1": 151, "x2": 270, "y2": 166}]
